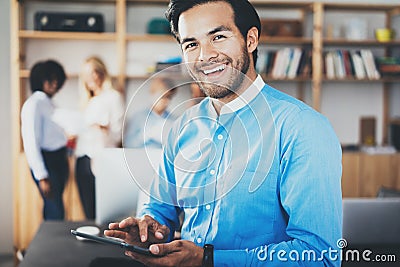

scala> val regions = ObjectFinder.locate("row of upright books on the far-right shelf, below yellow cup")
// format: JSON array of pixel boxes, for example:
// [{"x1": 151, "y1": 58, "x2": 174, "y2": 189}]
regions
[{"x1": 324, "y1": 49, "x2": 381, "y2": 80}]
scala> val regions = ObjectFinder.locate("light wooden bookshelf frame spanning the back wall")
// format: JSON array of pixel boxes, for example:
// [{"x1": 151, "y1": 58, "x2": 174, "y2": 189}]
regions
[{"x1": 10, "y1": 0, "x2": 400, "y2": 255}]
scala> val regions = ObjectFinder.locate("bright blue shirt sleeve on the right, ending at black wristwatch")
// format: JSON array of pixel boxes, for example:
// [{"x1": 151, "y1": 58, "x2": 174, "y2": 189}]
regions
[{"x1": 214, "y1": 110, "x2": 342, "y2": 266}]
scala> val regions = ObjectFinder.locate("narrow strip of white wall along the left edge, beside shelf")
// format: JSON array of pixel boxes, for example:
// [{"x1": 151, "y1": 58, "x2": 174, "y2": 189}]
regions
[{"x1": 0, "y1": 1, "x2": 13, "y2": 254}]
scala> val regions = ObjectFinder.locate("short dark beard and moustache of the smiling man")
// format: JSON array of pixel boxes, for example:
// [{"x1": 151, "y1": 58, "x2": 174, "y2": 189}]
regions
[{"x1": 190, "y1": 47, "x2": 250, "y2": 99}]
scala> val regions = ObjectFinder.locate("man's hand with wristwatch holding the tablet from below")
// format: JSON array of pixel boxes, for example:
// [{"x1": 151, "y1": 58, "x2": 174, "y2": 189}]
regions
[{"x1": 125, "y1": 240, "x2": 204, "y2": 267}]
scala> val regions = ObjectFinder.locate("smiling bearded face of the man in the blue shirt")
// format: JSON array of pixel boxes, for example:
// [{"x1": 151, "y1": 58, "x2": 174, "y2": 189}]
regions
[{"x1": 178, "y1": 1, "x2": 250, "y2": 98}]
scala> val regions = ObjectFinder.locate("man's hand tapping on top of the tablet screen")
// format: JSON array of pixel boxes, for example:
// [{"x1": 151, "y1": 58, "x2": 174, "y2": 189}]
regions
[{"x1": 104, "y1": 215, "x2": 170, "y2": 248}]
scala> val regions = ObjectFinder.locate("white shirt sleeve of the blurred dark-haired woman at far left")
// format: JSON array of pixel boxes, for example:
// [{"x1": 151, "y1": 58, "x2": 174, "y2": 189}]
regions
[{"x1": 21, "y1": 99, "x2": 49, "y2": 180}]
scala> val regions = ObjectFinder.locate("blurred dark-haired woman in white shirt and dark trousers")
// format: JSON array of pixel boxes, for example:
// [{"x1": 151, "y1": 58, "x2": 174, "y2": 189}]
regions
[{"x1": 21, "y1": 60, "x2": 69, "y2": 220}]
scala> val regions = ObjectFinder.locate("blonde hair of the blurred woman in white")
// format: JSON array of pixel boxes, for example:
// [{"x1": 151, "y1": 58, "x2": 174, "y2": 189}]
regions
[{"x1": 79, "y1": 56, "x2": 115, "y2": 109}]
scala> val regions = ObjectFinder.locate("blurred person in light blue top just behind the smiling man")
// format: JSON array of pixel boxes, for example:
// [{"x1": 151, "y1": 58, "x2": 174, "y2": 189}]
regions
[{"x1": 123, "y1": 78, "x2": 176, "y2": 149}]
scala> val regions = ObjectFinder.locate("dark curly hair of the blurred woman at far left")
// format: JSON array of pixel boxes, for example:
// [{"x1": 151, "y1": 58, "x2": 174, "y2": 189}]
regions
[{"x1": 29, "y1": 60, "x2": 66, "y2": 93}]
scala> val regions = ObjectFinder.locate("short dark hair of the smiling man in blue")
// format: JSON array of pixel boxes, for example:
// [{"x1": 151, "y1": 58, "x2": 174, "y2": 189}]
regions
[{"x1": 165, "y1": 0, "x2": 261, "y2": 67}]
